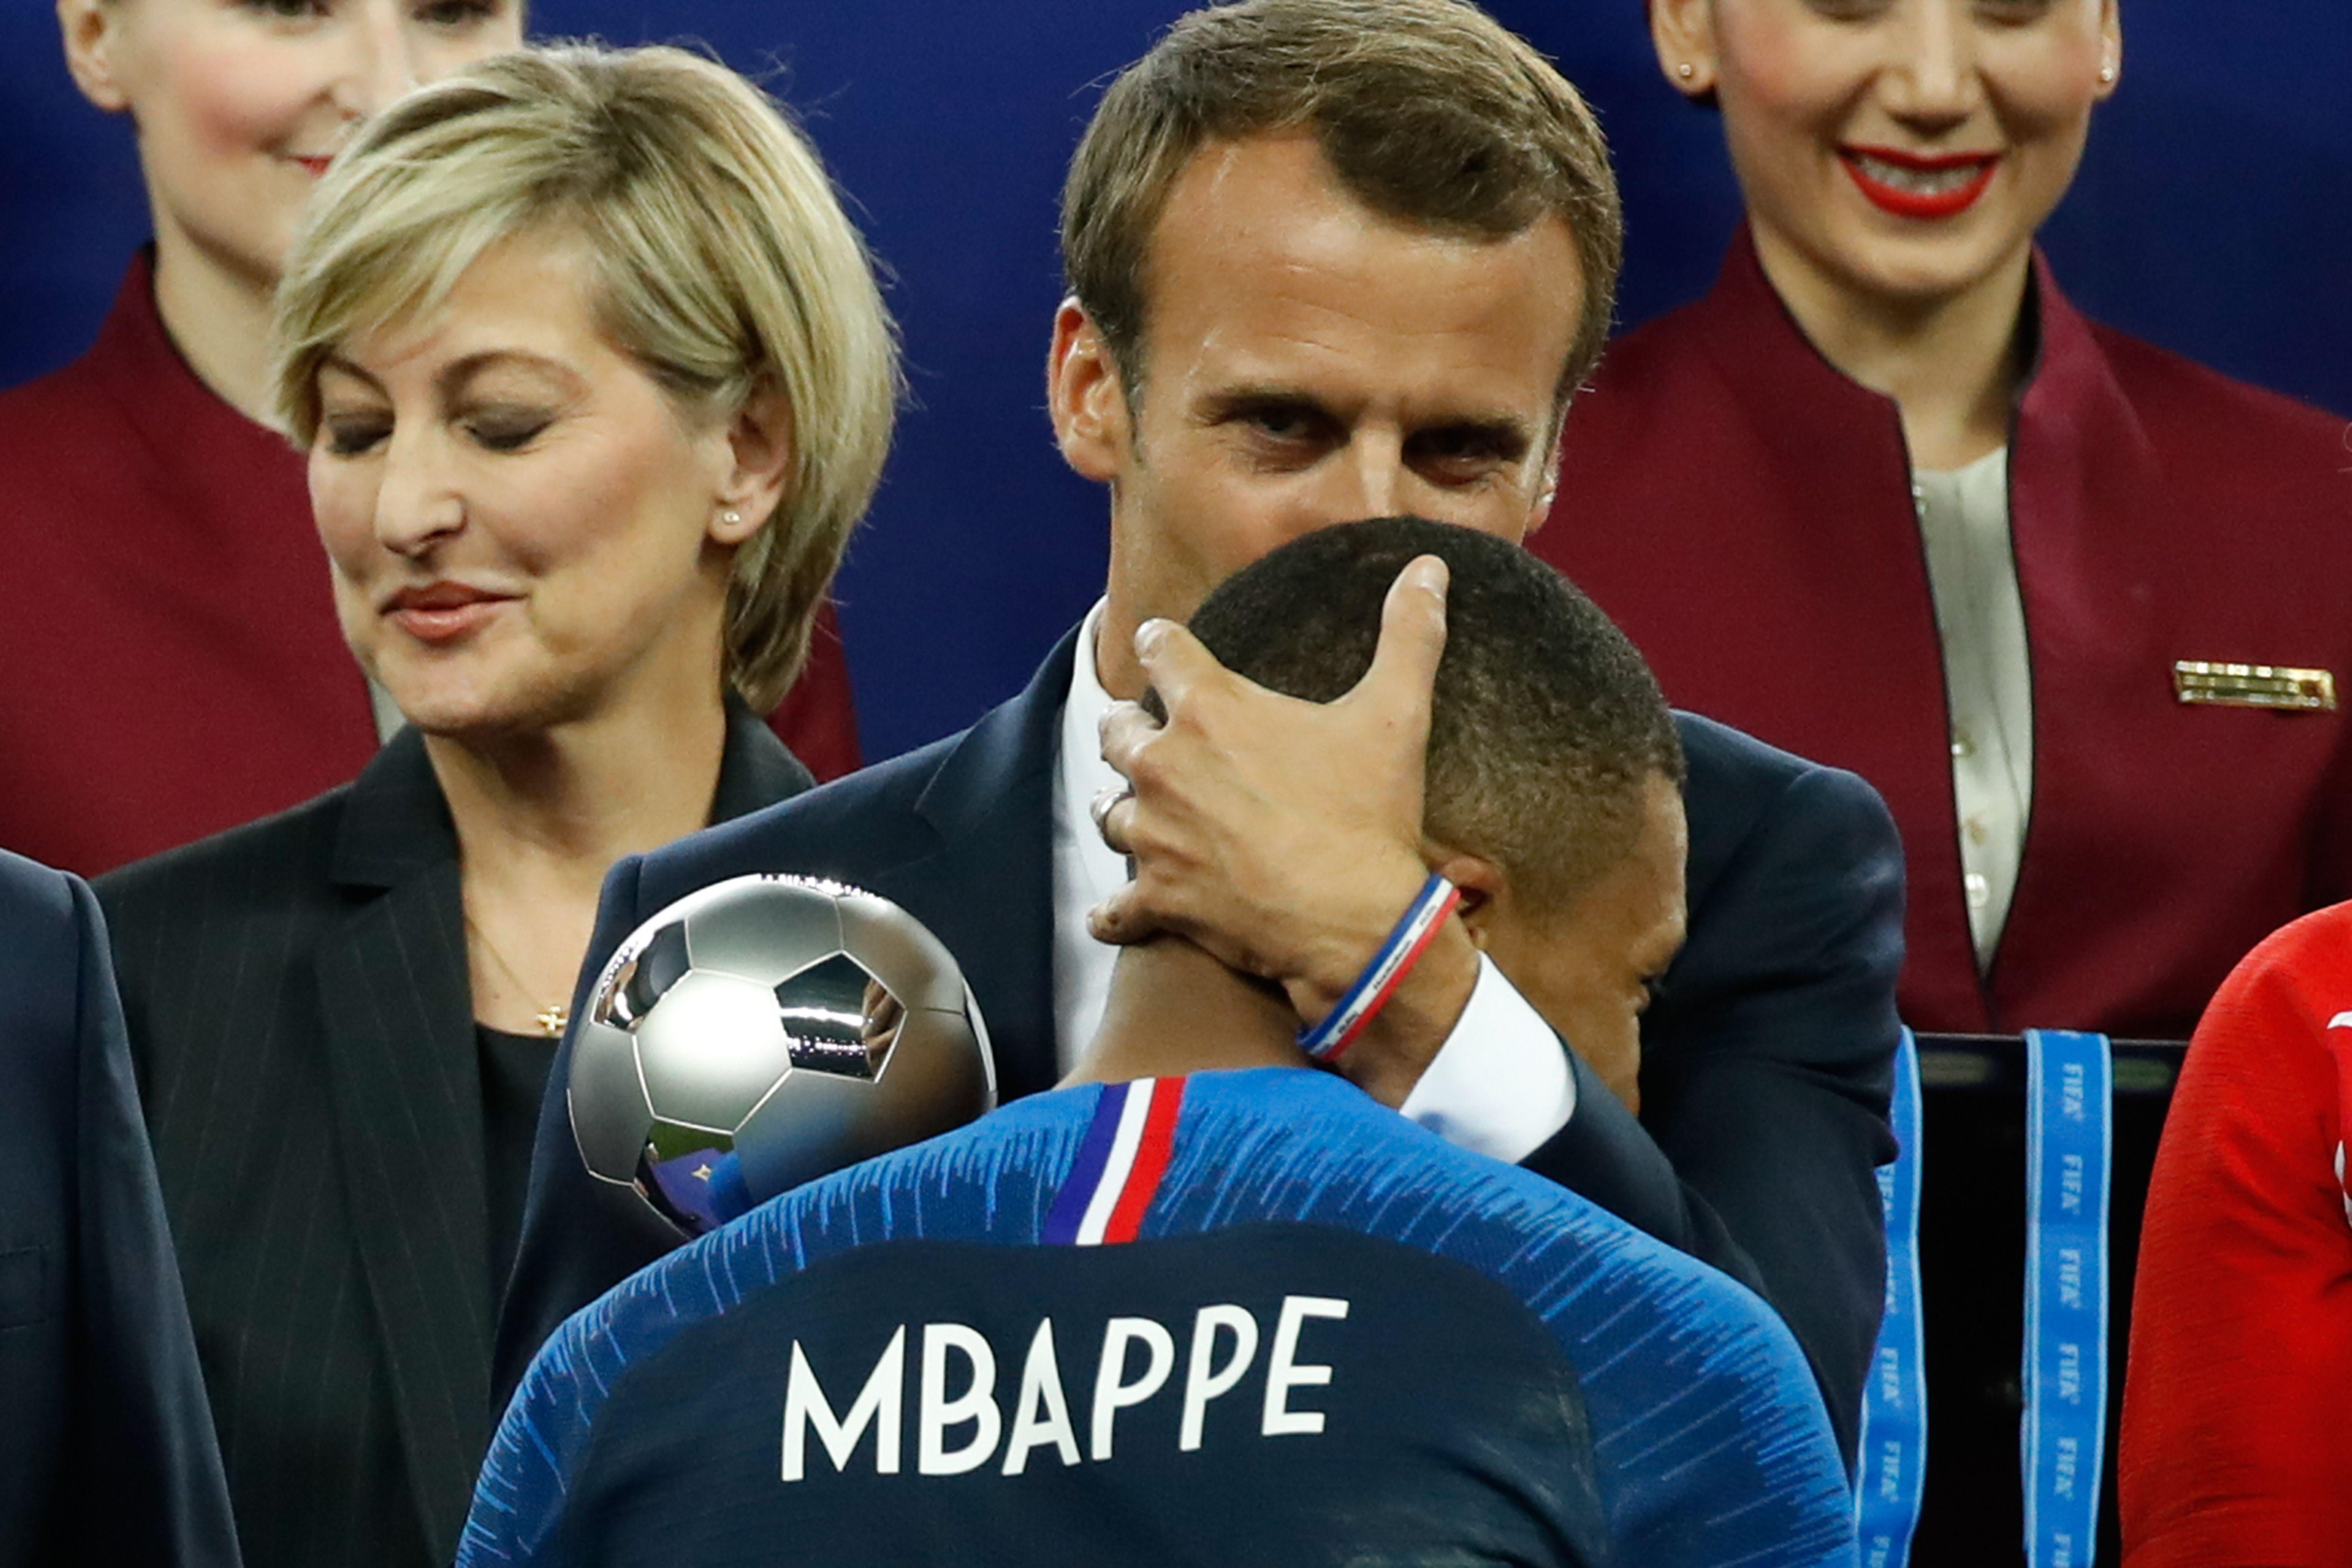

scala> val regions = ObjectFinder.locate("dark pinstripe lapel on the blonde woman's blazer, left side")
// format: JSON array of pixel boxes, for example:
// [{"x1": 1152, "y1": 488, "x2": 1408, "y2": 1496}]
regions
[{"x1": 318, "y1": 731, "x2": 492, "y2": 1561}]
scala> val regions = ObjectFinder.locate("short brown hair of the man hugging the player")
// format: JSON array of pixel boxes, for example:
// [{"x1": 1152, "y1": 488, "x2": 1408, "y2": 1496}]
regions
[{"x1": 1061, "y1": 0, "x2": 1625, "y2": 402}]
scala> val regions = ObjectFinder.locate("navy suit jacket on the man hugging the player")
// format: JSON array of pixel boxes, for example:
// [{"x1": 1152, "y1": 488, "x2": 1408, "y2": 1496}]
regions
[{"x1": 499, "y1": 620, "x2": 1903, "y2": 1455}]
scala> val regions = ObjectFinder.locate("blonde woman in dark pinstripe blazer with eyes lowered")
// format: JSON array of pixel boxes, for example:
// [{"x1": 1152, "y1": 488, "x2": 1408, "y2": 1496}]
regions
[{"x1": 101, "y1": 45, "x2": 898, "y2": 1566}]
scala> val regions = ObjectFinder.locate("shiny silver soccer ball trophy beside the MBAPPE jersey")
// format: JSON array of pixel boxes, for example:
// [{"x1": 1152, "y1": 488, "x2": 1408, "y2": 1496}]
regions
[{"x1": 564, "y1": 877, "x2": 997, "y2": 1237}]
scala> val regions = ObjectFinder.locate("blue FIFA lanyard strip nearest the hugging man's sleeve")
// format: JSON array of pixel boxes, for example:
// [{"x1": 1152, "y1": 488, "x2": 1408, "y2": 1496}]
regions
[{"x1": 1853, "y1": 1030, "x2": 1926, "y2": 1568}]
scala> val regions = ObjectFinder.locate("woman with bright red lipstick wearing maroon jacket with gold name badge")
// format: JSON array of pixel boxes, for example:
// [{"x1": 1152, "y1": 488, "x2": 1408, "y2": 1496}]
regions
[{"x1": 1536, "y1": 0, "x2": 2352, "y2": 1039}]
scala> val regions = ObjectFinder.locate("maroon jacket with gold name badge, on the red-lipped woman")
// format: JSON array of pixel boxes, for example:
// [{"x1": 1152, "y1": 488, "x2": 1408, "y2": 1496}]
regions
[{"x1": 1534, "y1": 235, "x2": 2352, "y2": 1039}]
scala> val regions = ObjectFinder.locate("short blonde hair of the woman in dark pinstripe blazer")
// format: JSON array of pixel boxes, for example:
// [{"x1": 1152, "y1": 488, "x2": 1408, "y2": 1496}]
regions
[{"x1": 275, "y1": 47, "x2": 896, "y2": 712}]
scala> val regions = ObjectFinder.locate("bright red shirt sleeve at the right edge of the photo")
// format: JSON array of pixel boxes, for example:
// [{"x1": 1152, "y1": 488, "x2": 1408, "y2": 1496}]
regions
[{"x1": 2117, "y1": 905, "x2": 2352, "y2": 1568}]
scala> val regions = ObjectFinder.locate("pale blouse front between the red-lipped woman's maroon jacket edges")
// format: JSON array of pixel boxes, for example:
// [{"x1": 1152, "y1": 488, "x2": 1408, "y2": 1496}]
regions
[{"x1": 1912, "y1": 447, "x2": 2034, "y2": 971}]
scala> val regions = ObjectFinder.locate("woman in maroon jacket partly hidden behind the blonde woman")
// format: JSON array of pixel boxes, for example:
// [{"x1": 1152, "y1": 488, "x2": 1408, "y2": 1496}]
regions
[{"x1": 0, "y1": 0, "x2": 858, "y2": 875}]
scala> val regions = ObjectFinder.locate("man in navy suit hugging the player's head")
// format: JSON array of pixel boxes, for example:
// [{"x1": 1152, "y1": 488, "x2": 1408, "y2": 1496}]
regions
[{"x1": 499, "y1": 0, "x2": 1903, "y2": 1460}]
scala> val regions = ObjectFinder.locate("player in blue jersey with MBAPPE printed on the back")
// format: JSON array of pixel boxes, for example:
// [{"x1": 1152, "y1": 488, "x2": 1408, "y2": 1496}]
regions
[{"x1": 459, "y1": 520, "x2": 1856, "y2": 1568}]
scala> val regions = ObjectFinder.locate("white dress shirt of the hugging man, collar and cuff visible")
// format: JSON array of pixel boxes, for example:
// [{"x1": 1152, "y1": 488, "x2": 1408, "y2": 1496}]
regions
[{"x1": 1054, "y1": 602, "x2": 1576, "y2": 1164}]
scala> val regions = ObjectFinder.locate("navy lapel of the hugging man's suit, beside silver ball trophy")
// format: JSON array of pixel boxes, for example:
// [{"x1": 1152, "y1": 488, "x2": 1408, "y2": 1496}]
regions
[{"x1": 873, "y1": 630, "x2": 1077, "y2": 1100}]
